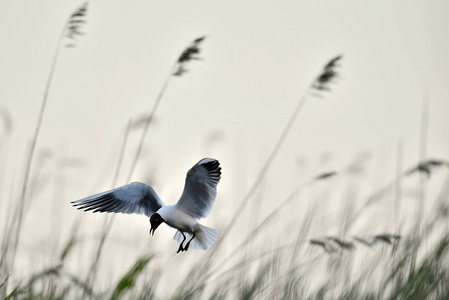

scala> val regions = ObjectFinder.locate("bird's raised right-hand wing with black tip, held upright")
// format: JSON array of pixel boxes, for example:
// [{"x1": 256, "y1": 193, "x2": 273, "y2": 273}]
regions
[{"x1": 176, "y1": 158, "x2": 221, "y2": 219}]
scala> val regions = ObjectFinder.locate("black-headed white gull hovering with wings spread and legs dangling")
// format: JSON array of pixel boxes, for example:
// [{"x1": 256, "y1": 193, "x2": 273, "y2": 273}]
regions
[{"x1": 71, "y1": 158, "x2": 221, "y2": 253}]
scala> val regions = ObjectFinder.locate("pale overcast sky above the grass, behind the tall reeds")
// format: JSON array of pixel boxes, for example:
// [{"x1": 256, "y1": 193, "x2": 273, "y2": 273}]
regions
[{"x1": 0, "y1": 0, "x2": 449, "y2": 286}]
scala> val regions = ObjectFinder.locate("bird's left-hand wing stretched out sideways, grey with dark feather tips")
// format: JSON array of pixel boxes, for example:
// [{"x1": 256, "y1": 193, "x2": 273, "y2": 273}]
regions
[{"x1": 72, "y1": 182, "x2": 164, "y2": 217}]
